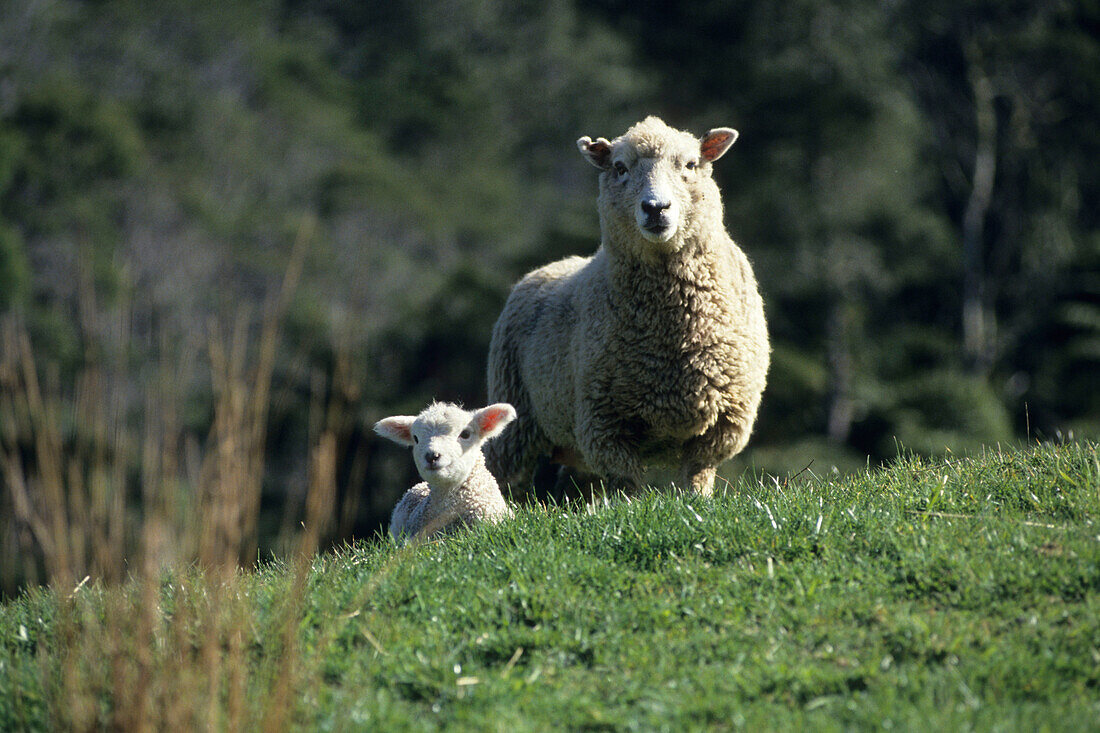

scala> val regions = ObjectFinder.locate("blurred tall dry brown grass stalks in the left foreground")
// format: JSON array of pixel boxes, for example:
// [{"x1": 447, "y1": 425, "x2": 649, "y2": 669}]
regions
[{"x1": 0, "y1": 220, "x2": 344, "y2": 731}]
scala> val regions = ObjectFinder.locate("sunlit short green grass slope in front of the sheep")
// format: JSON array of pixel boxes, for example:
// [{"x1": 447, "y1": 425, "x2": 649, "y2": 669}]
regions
[{"x1": 0, "y1": 435, "x2": 1100, "y2": 731}]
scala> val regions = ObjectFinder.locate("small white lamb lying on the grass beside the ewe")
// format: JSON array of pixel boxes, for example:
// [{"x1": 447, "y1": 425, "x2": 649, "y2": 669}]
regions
[{"x1": 374, "y1": 403, "x2": 516, "y2": 541}]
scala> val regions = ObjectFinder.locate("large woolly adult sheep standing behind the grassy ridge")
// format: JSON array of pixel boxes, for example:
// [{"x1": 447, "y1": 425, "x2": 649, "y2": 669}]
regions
[{"x1": 486, "y1": 117, "x2": 770, "y2": 495}]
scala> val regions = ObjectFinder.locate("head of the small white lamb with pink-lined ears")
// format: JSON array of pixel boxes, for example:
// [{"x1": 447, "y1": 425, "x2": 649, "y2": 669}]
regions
[{"x1": 374, "y1": 402, "x2": 516, "y2": 488}]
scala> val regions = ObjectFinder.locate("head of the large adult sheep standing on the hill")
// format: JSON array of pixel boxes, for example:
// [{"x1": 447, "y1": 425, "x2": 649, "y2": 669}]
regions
[{"x1": 576, "y1": 117, "x2": 737, "y2": 253}]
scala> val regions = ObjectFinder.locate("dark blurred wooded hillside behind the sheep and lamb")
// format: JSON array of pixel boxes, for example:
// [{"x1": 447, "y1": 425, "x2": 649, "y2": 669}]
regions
[{"x1": 0, "y1": 0, "x2": 1100, "y2": 585}]
